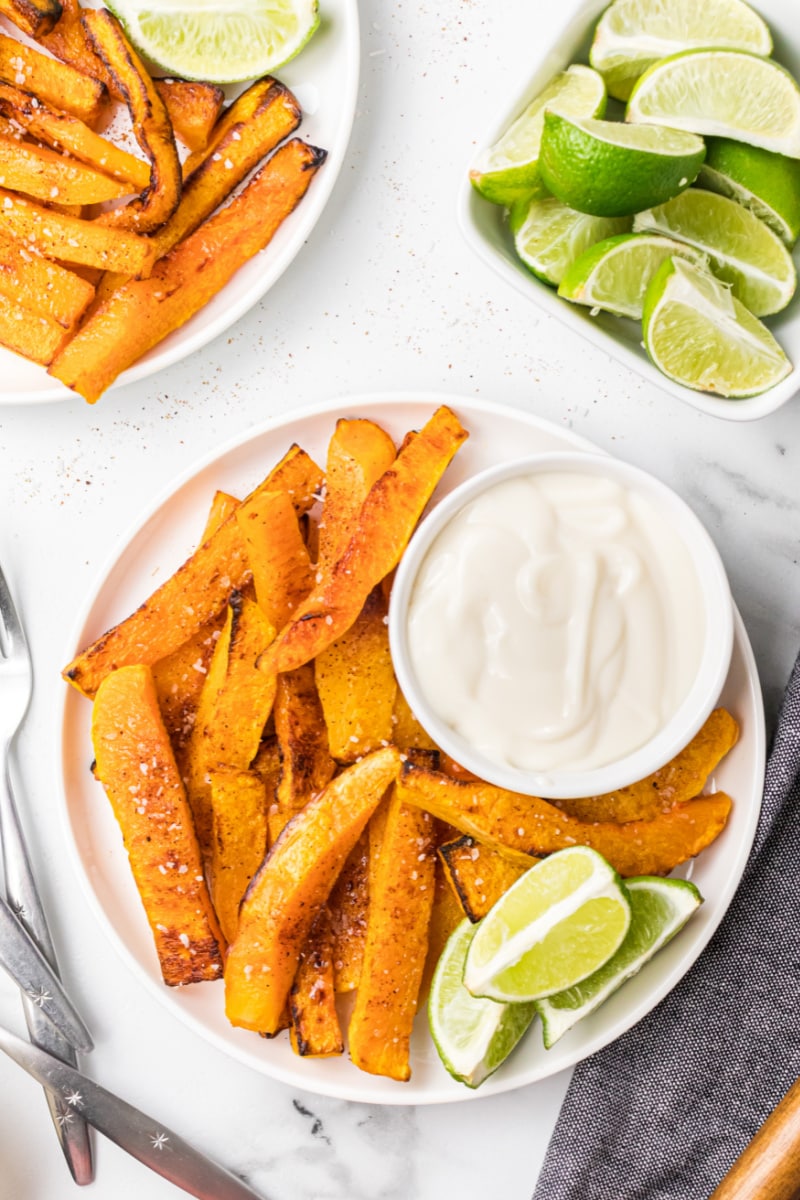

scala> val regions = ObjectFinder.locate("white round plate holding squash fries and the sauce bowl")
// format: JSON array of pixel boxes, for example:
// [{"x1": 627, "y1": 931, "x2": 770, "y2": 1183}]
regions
[{"x1": 62, "y1": 394, "x2": 765, "y2": 1104}]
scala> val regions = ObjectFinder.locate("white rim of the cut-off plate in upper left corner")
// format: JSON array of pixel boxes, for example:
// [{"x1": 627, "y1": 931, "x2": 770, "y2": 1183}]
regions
[{"x1": 0, "y1": 0, "x2": 361, "y2": 408}]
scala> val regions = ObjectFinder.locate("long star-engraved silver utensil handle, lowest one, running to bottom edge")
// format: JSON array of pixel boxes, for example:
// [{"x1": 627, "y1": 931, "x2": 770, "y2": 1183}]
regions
[{"x1": 0, "y1": 1026, "x2": 264, "y2": 1200}]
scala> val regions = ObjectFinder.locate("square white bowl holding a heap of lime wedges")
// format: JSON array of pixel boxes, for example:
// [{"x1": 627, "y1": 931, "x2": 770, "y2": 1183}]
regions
[{"x1": 458, "y1": 0, "x2": 800, "y2": 421}]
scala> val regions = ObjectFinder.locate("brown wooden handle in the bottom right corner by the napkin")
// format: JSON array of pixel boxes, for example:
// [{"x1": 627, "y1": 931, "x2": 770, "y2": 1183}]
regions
[{"x1": 711, "y1": 1080, "x2": 800, "y2": 1200}]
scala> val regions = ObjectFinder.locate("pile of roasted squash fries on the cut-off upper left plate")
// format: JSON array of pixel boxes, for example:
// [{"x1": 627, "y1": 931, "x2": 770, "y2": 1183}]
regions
[{"x1": 0, "y1": 0, "x2": 325, "y2": 402}]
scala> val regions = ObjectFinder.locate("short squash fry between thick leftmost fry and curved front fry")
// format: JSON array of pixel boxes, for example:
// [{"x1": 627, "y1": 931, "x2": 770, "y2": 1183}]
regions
[{"x1": 209, "y1": 767, "x2": 266, "y2": 942}]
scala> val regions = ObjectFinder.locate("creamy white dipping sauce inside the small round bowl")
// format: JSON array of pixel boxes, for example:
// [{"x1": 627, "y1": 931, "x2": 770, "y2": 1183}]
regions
[{"x1": 408, "y1": 470, "x2": 705, "y2": 772}]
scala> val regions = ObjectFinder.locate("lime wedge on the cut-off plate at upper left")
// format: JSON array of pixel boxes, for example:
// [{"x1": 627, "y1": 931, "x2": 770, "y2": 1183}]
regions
[{"x1": 109, "y1": 0, "x2": 319, "y2": 83}]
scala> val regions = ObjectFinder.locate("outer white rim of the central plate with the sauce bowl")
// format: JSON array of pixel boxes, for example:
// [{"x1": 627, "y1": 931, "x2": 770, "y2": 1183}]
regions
[{"x1": 55, "y1": 391, "x2": 766, "y2": 1106}]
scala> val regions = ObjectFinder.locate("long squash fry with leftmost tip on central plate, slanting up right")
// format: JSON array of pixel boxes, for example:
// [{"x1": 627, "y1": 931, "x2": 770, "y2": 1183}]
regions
[{"x1": 64, "y1": 445, "x2": 321, "y2": 696}]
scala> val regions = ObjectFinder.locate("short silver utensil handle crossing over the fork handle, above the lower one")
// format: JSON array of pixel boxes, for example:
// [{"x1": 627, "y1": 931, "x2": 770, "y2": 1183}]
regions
[{"x1": 0, "y1": 896, "x2": 92, "y2": 1051}]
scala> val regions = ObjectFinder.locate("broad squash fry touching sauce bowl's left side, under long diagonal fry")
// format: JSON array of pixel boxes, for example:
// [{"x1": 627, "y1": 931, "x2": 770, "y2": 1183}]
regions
[{"x1": 314, "y1": 587, "x2": 397, "y2": 762}]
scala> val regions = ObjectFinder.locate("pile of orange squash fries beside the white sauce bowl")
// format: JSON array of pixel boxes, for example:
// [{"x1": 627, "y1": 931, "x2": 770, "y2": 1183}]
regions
[{"x1": 64, "y1": 407, "x2": 738, "y2": 1080}]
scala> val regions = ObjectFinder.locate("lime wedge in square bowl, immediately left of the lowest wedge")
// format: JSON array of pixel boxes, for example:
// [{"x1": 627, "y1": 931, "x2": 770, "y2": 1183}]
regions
[{"x1": 559, "y1": 233, "x2": 708, "y2": 320}]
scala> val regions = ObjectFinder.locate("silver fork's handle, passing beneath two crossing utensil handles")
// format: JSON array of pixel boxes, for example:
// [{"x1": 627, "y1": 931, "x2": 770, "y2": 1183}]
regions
[{"x1": 0, "y1": 749, "x2": 95, "y2": 1187}]
